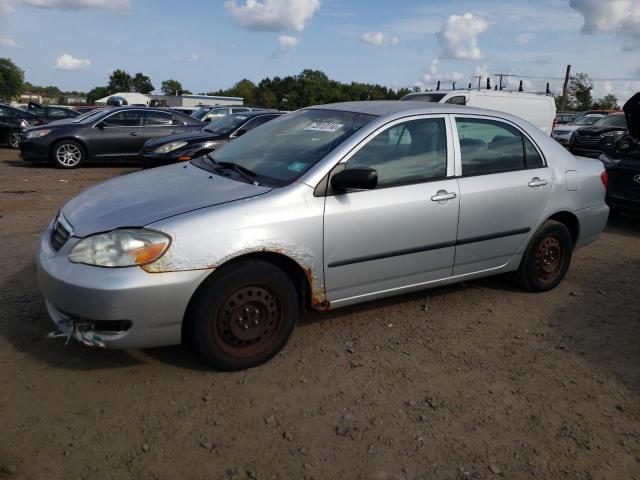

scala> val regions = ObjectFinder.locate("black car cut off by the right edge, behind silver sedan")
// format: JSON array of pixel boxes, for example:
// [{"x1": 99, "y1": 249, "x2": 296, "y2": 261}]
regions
[{"x1": 600, "y1": 92, "x2": 640, "y2": 216}]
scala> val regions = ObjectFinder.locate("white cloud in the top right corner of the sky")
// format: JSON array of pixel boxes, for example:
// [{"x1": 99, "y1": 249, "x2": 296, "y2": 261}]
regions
[{"x1": 569, "y1": 0, "x2": 640, "y2": 50}]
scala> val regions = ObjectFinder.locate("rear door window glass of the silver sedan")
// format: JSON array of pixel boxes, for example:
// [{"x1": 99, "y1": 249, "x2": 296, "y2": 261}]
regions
[{"x1": 456, "y1": 118, "x2": 544, "y2": 176}]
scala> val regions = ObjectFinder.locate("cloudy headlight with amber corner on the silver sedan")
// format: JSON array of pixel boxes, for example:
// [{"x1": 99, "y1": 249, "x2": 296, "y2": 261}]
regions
[{"x1": 69, "y1": 229, "x2": 171, "y2": 267}]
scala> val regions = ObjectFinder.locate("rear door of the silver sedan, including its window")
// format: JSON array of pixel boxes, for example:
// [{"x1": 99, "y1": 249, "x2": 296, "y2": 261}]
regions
[{"x1": 453, "y1": 115, "x2": 552, "y2": 275}]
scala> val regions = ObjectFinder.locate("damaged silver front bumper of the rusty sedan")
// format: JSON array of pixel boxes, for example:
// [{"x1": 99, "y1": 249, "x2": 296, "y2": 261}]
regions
[{"x1": 36, "y1": 218, "x2": 210, "y2": 348}]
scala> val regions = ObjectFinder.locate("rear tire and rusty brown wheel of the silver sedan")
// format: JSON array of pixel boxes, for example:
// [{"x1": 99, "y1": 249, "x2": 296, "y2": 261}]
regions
[{"x1": 515, "y1": 220, "x2": 573, "y2": 292}]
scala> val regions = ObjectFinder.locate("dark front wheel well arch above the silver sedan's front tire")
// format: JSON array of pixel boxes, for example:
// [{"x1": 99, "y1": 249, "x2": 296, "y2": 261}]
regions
[{"x1": 182, "y1": 252, "x2": 311, "y2": 341}]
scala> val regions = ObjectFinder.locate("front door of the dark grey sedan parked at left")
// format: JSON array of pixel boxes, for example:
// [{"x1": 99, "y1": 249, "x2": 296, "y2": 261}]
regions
[{"x1": 86, "y1": 108, "x2": 144, "y2": 159}]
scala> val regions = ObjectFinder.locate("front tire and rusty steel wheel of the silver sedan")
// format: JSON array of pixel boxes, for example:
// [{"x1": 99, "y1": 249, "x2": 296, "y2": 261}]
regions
[{"x1": 185, "y1": 260, "x2": 300, "y2": 371}]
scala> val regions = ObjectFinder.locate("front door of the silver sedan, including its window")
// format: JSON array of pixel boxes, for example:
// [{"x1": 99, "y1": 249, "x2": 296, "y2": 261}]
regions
[{"x1": 324, "y1": 116, "x2": 459, "y2": 303}]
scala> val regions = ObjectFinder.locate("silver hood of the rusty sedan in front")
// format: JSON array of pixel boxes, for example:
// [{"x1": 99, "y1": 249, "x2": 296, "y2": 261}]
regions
[{"x1": 62, "y1": 164, "x2": 271, "y2": 237}]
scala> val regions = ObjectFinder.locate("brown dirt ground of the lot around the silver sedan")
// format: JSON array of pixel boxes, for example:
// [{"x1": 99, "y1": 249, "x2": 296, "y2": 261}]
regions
[{"x1": 0, "y1": 149, "x2": 640, "y2": 480}]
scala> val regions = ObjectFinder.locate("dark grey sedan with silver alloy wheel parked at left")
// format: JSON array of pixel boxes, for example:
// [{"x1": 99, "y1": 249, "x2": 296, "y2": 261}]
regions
[{"x1": 20, "y1": 107, "x2": 204, "y2": 168}]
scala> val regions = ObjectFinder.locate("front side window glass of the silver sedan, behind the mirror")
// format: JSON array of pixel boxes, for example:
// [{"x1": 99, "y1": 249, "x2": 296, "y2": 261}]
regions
[{"x1": 345, "y1": 118, "x2": 447, "y2": 188}]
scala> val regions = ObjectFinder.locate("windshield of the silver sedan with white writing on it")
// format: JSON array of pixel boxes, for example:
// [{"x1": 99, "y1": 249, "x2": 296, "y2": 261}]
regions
[{"x1": 192, "y1": 109, "x2": 376, "y2": 186}]
